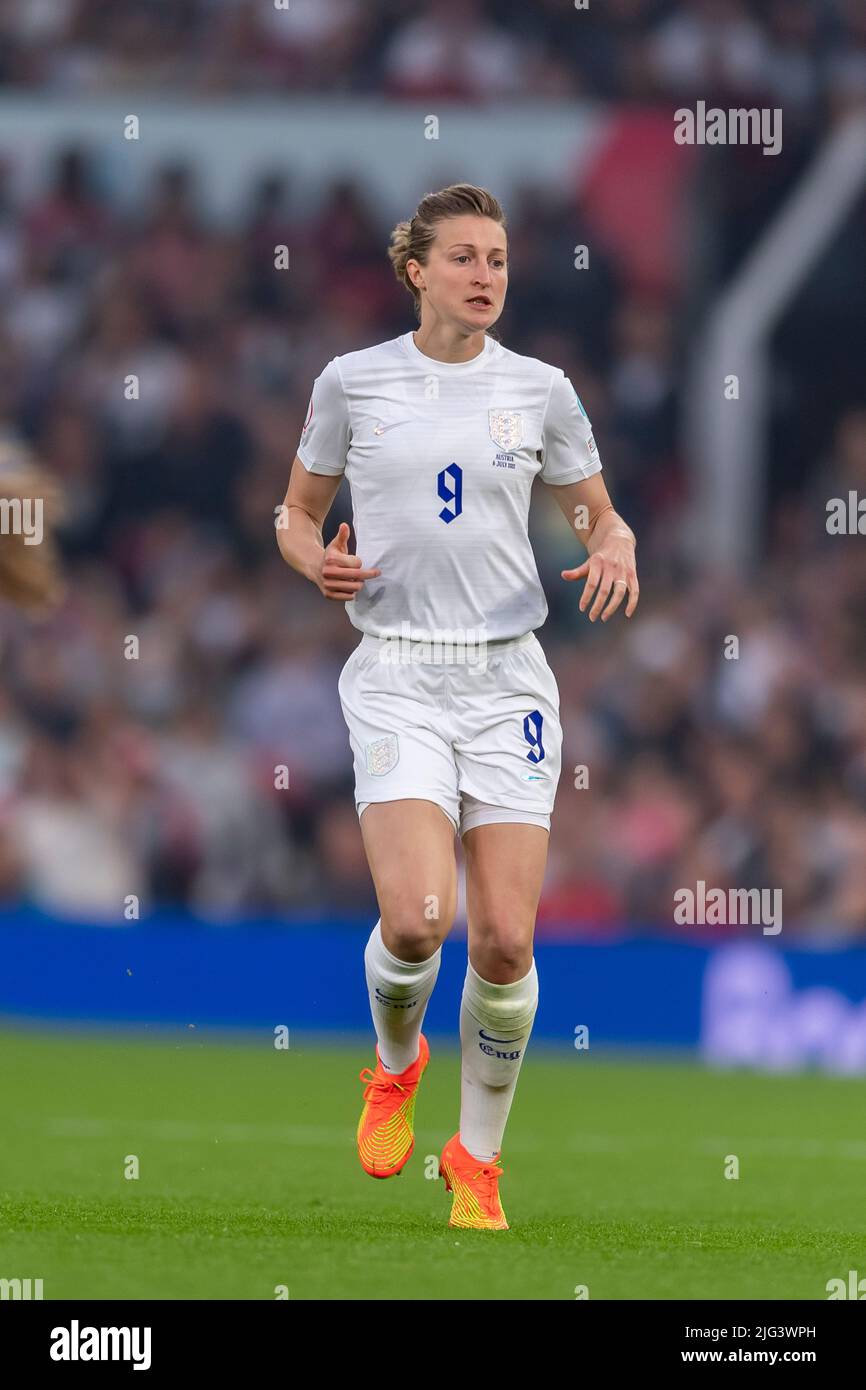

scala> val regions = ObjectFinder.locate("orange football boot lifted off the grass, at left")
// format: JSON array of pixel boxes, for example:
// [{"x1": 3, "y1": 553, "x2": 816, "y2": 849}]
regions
[{"x1": 357, "y1": 1033, "x2": 430, "y2": 1177}]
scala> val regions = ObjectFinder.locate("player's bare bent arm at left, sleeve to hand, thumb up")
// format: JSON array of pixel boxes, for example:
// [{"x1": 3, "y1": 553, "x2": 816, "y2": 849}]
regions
[{"x1": 277, "y1": 456, "x2": 381, "y2": 603}]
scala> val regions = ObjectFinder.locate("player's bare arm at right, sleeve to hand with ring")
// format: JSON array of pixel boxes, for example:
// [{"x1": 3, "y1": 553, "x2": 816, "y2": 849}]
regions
[{"x1": 545, "y1": 473, "x2": 641, "y2": 623}]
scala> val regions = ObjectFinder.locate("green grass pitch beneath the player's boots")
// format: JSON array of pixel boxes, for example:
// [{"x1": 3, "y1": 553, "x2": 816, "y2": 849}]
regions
[{"x1": 0, "y1": 1029, "x2": 866, "y2": 1300}]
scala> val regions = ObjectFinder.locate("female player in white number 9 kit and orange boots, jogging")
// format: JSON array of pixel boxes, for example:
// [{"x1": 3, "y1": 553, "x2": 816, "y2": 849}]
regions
[{"x1": 277, "y1": 183, "x2": 638, "y2": 1230}]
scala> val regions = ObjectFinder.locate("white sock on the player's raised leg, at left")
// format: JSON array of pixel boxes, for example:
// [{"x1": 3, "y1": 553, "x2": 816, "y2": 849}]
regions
[{"x1": 364, "y1": 917, "x2": 442, "y2": 1073}]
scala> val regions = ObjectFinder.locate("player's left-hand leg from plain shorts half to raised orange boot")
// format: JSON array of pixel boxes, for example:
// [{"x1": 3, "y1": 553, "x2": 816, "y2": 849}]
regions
[{"x1": 339, "y1": 637, "x2": 460, "y2": 1177}]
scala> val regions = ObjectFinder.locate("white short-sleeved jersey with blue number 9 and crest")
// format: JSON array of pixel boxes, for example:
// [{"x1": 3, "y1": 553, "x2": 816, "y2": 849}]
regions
[{"x1": 297, "y1": 332, "x2": 602, "y2": 642}]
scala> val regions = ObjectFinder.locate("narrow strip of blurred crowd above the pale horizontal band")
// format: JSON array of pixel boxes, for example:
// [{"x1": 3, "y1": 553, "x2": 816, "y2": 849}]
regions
[{"x1": 0, "y1": 0, "x2": 866, "y2": 117}]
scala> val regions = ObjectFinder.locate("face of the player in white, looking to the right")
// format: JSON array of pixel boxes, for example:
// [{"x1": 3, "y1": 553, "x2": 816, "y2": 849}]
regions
[{"x1": 423, "y1": 214, "x2": 509, "y2": 332}]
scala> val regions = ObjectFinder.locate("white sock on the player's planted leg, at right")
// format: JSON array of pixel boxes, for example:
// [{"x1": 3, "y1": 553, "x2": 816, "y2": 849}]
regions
[{"x1": 460, "y1": 959, "x2": 538, "y2": 1161}]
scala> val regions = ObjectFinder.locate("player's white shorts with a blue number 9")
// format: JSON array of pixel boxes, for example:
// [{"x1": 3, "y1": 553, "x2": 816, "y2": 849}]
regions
[{"x1": 338, "y1": 632, "x2": 562, "y2": 835}]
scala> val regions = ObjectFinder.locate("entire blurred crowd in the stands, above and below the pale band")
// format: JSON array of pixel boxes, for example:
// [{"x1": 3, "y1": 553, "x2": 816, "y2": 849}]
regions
[{"x1": 0, "y1": 0, "x2": 866, "y2": 940}]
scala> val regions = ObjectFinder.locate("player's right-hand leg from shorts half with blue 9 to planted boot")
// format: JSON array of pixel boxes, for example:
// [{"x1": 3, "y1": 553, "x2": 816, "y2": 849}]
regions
[{"x1": 441, "y1": 635, "x2": 562, "y2": 1229}]
